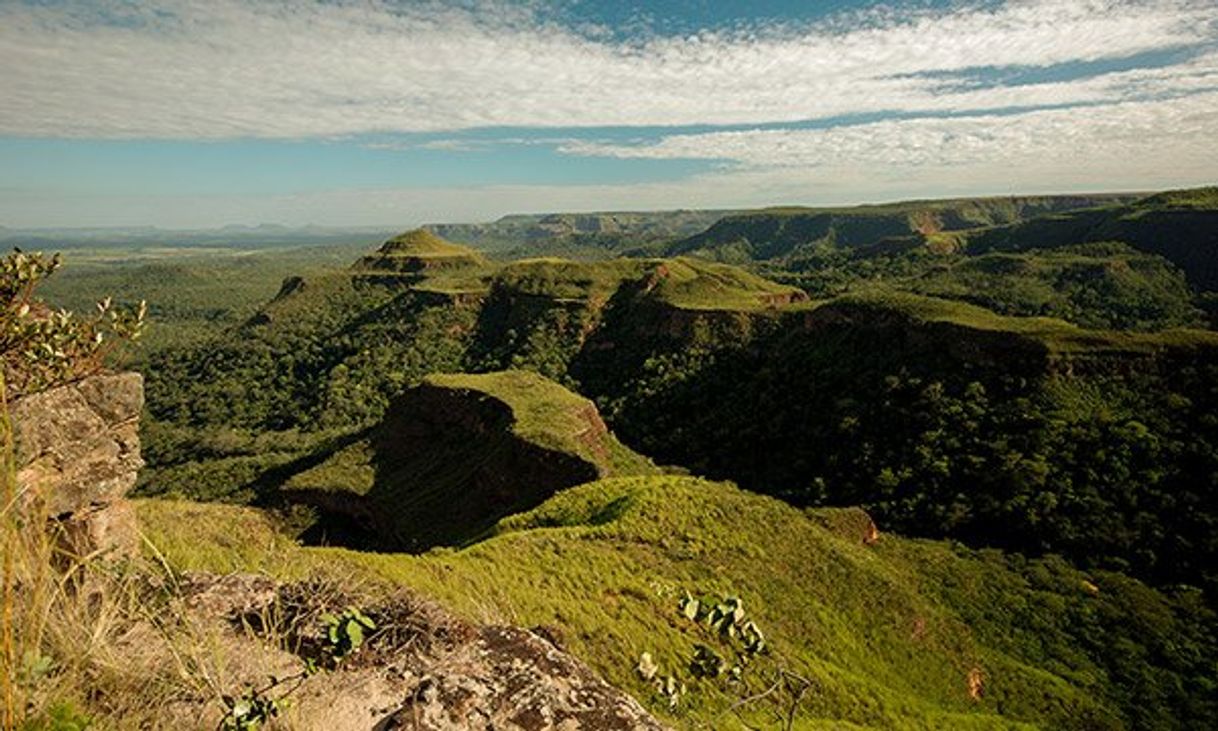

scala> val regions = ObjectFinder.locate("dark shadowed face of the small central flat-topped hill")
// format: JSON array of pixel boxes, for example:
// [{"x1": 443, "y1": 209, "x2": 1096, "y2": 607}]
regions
[{"x1": 278, "y1": 386, "x2": 599, "y2": 553}]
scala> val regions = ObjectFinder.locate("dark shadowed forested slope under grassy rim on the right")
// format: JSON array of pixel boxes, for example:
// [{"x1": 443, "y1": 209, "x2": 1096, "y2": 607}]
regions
[{"x1": 605, "y1": 291, "x2": 1218, "y2": 587}]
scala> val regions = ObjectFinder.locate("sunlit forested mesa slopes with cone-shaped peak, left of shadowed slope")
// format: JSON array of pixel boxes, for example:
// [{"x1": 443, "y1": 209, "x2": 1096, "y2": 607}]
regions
[{"x1": 141, "y1": 248, "x2": 800, "y2": 500}]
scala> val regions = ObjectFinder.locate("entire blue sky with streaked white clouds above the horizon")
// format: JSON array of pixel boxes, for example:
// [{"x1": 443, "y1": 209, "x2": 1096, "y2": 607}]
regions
[{"x1": 0, "y1": 0, "x2": 1218, "y2": 228}]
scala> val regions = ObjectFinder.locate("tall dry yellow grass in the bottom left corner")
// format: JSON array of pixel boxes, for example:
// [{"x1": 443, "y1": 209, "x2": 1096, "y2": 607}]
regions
[{"x1": 0, "y1": 381, "x2": 286, "y2": 731}]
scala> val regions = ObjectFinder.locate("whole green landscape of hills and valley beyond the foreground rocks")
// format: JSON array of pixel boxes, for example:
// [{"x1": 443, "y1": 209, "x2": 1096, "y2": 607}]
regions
[{"x1": 9, "y1": 189, "x2": 1218, "y2": 730}]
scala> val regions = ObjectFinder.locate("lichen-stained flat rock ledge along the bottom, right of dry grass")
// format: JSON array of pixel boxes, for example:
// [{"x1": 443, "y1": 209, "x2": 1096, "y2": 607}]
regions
[{"x1": 174, "y1": 574, "x2": 664, "y2": 731}]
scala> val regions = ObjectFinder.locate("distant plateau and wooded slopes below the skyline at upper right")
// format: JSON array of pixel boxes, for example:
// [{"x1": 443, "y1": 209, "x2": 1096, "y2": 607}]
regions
[{"x1": 666, "y1": 189, "x2": 1218, "y2": 330}]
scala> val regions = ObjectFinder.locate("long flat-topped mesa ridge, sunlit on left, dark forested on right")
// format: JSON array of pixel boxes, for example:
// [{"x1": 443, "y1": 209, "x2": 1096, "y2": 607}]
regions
[{"x1": 135, "y1": 233, "x2": 1218, "y2": 594}]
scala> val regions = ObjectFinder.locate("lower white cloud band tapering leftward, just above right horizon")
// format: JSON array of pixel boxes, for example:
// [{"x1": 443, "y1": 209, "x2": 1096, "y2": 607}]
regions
[{"x1": 561, "y1": 91, "x2": 1218, "y2": 174}]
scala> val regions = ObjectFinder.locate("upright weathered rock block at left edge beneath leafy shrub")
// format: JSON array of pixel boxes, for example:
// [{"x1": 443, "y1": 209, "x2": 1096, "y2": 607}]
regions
[{"x1": 11, "y1": 373, "x2": 144, "y2": 553}]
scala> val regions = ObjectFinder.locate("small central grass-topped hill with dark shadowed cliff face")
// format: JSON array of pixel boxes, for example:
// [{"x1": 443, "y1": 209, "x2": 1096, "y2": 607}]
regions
[{"x1": 280, "y1": 370, "x2": 654, "y2": 551}]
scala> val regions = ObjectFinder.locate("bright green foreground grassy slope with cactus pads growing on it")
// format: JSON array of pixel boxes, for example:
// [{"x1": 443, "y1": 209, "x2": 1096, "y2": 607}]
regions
[{"x1": 140, "y1": 478, "x2": 1216, "y2": 730}]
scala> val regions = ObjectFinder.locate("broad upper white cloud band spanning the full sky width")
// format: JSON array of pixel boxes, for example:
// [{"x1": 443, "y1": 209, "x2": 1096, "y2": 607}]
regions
[{"x1": 0, "y1": 0, "x2": 1218, "y2": 139}]
